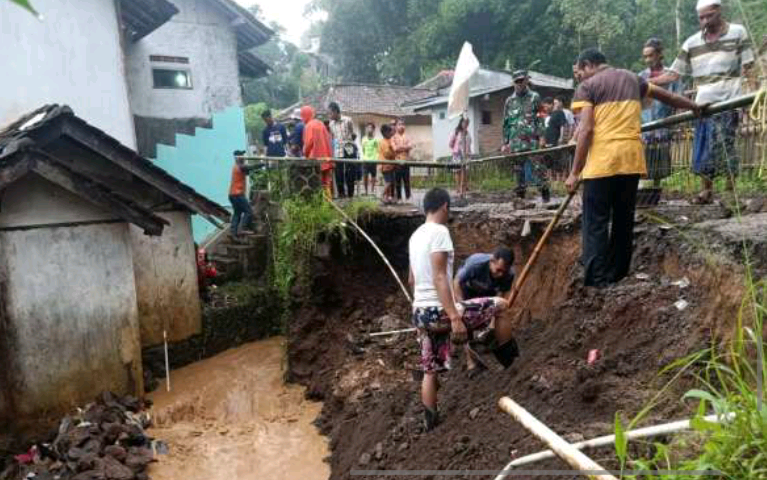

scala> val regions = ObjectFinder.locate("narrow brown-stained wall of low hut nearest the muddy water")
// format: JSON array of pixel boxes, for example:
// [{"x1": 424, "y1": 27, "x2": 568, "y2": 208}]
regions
[{"x1": 131, "y1": 212, "x2": 202, "y2": 347}]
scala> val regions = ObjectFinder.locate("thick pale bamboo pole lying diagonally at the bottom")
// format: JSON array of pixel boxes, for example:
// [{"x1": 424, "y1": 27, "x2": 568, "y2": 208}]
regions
[{"x1": 498, "y1": 397, "x2": 618, "y2": 480}]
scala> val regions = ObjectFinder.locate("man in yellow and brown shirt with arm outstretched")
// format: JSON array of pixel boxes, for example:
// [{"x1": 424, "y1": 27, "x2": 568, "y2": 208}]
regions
[{"x1": 565, "y1": 49, "x2": 702, "y2": 287}]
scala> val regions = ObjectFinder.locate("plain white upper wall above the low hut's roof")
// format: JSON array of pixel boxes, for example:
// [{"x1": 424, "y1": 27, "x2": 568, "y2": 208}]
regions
[{"x1": 0, "y1": 0, "x2": 135, "y2": 147}]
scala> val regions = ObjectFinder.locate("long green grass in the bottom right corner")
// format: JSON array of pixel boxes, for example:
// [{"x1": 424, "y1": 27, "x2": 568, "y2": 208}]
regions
[{"x1": 615, "y1": 196, "x2": 767, "y2": 480}]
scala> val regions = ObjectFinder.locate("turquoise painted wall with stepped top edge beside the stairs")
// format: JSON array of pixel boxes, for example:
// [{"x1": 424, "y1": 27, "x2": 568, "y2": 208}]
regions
[{"x1": 155, "y1": 107, "x2": 248, "y2": 242}]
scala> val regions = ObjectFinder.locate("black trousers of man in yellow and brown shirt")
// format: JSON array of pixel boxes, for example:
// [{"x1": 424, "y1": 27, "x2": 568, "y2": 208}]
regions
[{"x1": 581, "y1": 175, "x2": 639, "y2": 287}]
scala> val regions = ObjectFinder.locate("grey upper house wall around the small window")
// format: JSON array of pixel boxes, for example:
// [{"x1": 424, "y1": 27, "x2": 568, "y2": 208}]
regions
[{"x1": 126, "y1": 0, "x2": 242, "y2": 118}]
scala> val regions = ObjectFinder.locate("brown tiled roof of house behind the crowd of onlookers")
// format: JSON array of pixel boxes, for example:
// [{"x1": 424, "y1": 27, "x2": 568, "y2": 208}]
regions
[{"x1": 279, "y1": 83, "x2": 434, "y2": 119}]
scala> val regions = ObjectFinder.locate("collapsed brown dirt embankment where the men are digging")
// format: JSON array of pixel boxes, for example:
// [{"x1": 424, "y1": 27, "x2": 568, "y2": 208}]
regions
[{"x1": 289, "y1": 206, "x2": 764, "y2": 479}]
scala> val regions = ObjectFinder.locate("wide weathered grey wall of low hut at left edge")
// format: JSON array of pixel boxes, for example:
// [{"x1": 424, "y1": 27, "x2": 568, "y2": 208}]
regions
[{"x1": 0, "y1": 180, "x2": 143, "y2": 420}]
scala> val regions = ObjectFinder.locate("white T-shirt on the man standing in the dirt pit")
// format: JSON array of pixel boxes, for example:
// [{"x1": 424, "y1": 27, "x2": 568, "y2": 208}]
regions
[{"x1": 409, "y1": 222, "x2": 455, "y2": 308}]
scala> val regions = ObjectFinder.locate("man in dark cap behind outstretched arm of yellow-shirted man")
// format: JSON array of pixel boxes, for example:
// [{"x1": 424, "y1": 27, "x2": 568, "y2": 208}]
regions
[{"x1": 639, "y1": 38, "x2": 682, "y2": 187}]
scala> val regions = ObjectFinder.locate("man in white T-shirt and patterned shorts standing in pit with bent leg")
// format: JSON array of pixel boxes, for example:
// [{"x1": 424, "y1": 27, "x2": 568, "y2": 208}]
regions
[{"x1": 409, "y1": 188, "x2": 517, "y2": 430}]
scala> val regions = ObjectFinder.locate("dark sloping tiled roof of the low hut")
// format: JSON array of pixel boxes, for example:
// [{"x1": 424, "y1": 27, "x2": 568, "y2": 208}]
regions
[{"x1": 0, "y1": 104, "x2": 230, "y2": 222}]
